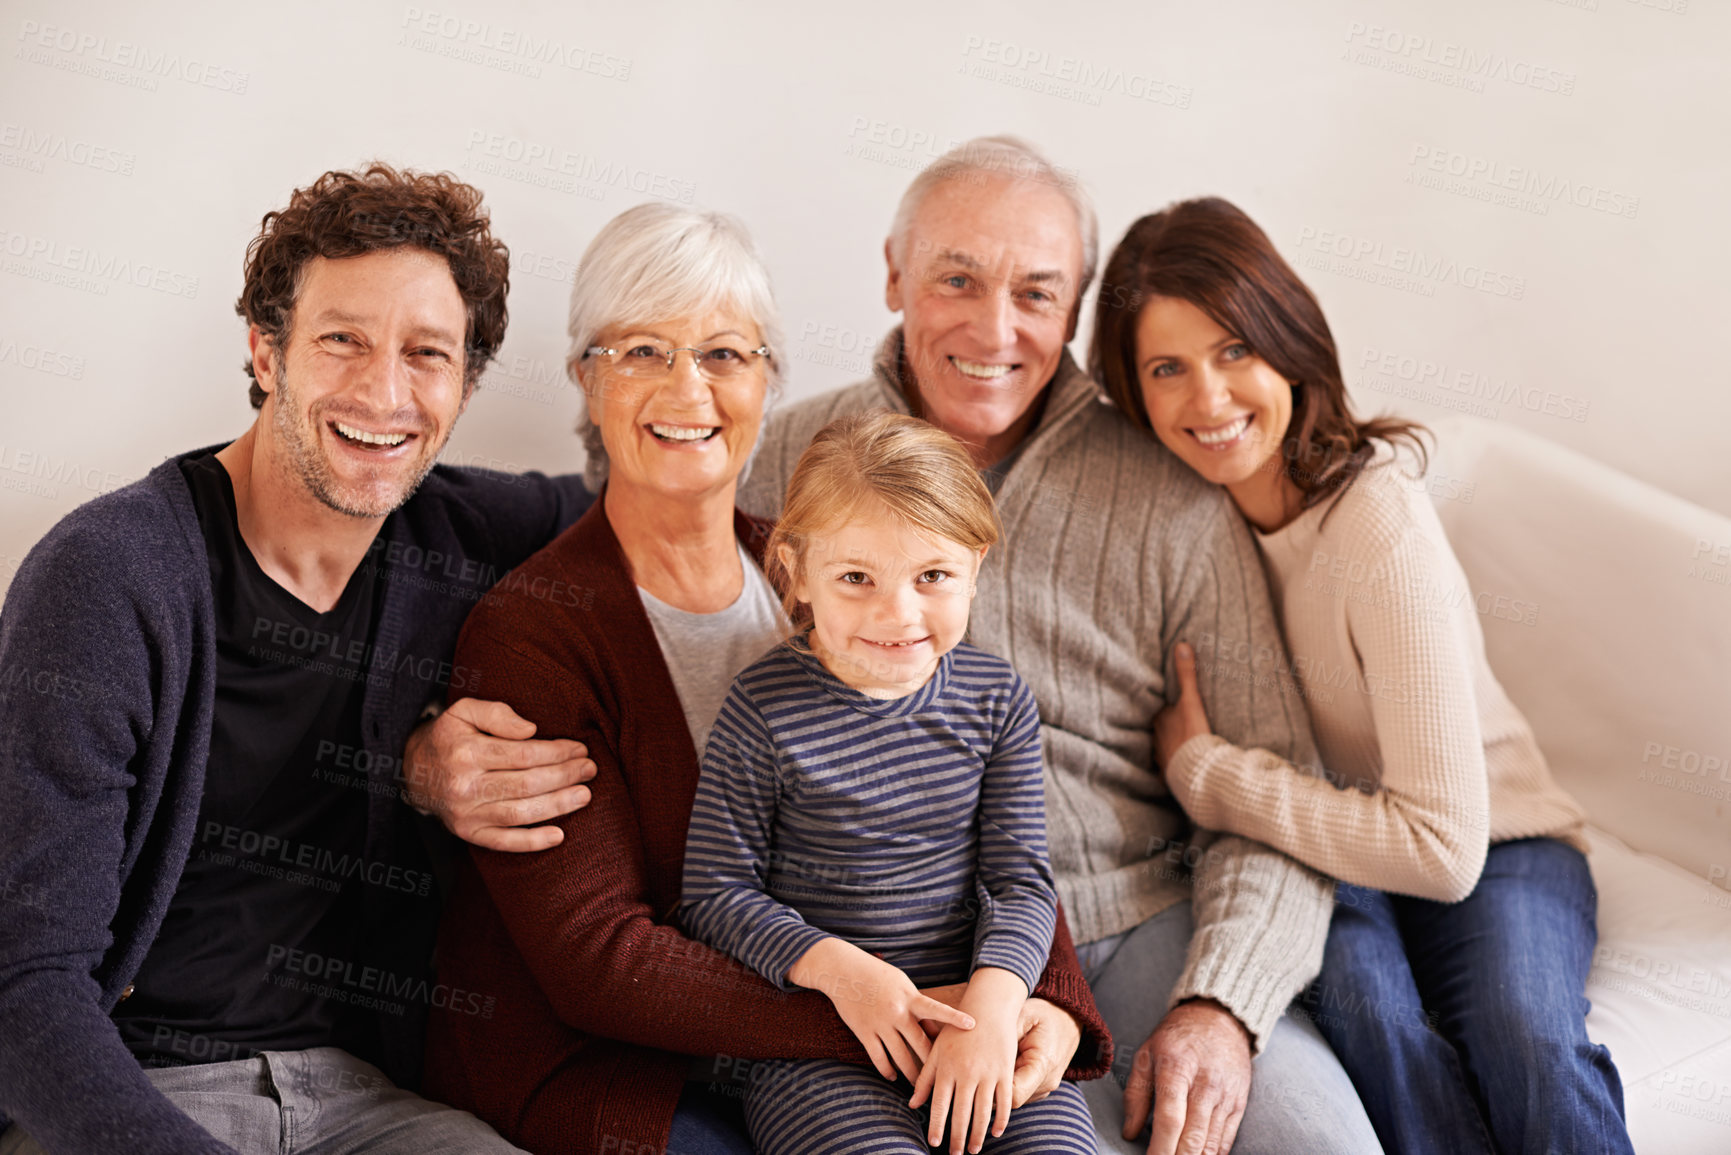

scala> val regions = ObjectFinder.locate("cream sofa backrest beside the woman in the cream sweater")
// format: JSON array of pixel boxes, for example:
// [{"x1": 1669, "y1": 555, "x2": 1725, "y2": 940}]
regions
[{"x1": 1428, "y1": 419, "x2": 1731, "y2": 886}]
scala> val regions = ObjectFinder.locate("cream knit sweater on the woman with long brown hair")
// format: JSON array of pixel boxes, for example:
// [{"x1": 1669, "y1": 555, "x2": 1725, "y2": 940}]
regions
[{"x1": 1167, "y1": 450, "x2": 1587, "y2": 902}]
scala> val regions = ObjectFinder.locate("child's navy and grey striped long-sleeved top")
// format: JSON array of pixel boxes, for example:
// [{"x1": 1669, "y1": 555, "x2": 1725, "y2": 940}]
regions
[{"x1": 680, "y1": 642, "x2": 1058, "y2": 990}]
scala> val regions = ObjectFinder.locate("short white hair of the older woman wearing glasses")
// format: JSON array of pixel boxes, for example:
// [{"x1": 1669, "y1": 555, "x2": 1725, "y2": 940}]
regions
[{"x1": 564, "y1": 201, "x2": 784, "y2": 494}]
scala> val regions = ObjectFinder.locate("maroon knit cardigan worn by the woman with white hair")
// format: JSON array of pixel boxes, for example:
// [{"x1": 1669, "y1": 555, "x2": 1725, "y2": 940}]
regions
[{"x1": 424, "y1": 500, "x2": 1111, "y2": 1155}]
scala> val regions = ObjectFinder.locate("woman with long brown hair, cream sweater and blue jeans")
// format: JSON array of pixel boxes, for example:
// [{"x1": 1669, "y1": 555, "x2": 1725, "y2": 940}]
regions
[{"x1": 1091, "y1": 199, "x2": 1631, "y2": 1153}]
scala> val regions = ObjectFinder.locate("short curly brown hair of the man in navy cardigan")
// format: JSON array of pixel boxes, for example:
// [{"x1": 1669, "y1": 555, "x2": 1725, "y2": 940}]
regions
[{"x1": 234, "y1": 161, "x2": 511, "y2": 409}]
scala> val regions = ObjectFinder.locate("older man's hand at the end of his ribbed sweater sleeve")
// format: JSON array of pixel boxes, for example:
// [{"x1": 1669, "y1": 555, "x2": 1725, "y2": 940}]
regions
[{"x1": 1123, "y1": 999, "x2": 1250, "y2": 1155}]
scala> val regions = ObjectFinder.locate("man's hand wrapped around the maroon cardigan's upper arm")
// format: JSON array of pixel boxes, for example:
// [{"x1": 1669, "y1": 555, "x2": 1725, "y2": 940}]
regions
[{"x1": 403, "y1": 698, "x2": 595, "y2": 852}]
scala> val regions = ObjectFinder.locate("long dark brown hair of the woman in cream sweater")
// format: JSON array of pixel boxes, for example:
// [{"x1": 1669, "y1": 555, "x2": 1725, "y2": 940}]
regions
[{"x1": 1089, "y1": 197, "x2": 1430, "y2": 509}]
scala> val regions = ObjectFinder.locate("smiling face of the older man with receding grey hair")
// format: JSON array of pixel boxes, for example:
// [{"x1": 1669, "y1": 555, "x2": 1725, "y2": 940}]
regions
[{"x1": 885, "y1": 173, "x2": 1082, "y2": 466}]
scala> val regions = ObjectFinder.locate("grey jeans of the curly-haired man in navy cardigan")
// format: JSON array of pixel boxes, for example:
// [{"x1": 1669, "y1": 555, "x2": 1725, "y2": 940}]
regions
[{"x1": 0, "y1": 1046, "x2": 523, "y2": 1155}]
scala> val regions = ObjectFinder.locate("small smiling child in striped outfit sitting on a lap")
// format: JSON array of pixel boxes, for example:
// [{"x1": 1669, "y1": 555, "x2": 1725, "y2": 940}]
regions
[{"x1": 680, "y1": 410, "x2": 1094, "y2": 1155}]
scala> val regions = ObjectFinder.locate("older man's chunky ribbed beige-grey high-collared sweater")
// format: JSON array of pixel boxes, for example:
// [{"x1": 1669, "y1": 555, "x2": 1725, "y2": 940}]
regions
[{"x1": 737, "y1": 329, "x2": 1333, "y2": 1051}]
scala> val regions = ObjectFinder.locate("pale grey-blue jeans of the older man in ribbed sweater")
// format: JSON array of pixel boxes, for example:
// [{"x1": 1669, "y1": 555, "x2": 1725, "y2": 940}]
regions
[{"x1": 1073, "y1": 902, "x2": 1383, "y2": 1155}]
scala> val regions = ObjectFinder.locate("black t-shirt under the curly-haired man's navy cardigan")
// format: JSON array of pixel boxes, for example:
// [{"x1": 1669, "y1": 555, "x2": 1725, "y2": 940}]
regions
[{"x1": 114, "y1": 455, "x2": 383, "y2": 1067}]
